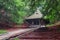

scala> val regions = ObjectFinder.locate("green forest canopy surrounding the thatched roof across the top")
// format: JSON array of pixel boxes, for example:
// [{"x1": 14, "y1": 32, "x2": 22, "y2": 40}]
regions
[{"x1": 0, "y1": 0, "x2": 60, "y2": 24}]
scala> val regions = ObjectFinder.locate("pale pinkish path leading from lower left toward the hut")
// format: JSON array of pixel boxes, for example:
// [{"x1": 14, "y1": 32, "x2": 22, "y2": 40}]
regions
[{"x1": 0, "y1": 29, "x2": 31, "y2": 40}]
